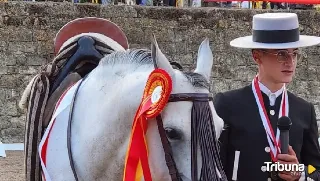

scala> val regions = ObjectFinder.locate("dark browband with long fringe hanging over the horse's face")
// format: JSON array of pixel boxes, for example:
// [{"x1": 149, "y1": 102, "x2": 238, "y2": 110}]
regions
[{"x1": 162, "y1": 93, "x2": 227, "y2": 181}]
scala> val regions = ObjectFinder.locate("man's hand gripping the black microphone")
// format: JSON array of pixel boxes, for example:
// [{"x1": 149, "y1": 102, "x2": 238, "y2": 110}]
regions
[{"x1": 278, "y1": 146, "x2": 301, "y2": 181}]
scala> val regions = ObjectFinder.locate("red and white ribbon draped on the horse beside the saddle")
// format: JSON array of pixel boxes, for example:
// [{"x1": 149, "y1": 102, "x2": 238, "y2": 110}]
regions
[{"x1": 39, "y1": 79, "x2": 83, "y2": 181}]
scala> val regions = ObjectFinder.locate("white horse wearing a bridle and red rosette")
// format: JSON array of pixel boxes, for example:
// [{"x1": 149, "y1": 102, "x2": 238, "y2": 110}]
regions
[{"x1": 22, "y1": 34, "x2": 223, "y2": 181}]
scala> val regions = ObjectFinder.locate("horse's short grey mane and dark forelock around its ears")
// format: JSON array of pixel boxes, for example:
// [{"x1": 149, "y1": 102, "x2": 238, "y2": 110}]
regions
[{"x1": 100, "y1": 49, "x2": 210, "y2": 91}]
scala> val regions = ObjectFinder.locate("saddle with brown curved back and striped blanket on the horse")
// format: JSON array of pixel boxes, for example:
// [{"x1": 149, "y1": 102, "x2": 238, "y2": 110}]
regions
[{"x1": 24, "y1": 18, "x2": 128, "y2": 181}]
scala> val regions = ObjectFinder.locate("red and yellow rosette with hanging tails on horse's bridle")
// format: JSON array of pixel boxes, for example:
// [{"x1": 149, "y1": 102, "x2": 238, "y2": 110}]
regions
[{"x1": 123, "y1": 69, "x2": 172, "y2": 181}]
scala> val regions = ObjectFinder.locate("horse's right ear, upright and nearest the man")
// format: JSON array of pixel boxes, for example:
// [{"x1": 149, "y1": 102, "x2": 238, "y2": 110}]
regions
[{"x1": 194, "y1": 38, "x2": 213, "y2": 81}]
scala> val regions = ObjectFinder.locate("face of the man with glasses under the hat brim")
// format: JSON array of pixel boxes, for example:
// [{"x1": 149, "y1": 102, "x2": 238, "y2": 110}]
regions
[{"x1": 253, "y1": 49, "x2": 301, "y2": 83}]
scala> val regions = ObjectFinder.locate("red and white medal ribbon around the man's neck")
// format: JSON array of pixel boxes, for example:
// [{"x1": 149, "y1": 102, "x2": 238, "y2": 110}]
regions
[{"x1": 252, "y1": 76, "x2": 289, "y2": 162}]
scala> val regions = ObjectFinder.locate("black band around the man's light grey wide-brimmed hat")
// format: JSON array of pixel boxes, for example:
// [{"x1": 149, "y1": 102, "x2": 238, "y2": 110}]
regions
[{"x1": 252, "y1": 28, "x2": 300, "y2": 43}]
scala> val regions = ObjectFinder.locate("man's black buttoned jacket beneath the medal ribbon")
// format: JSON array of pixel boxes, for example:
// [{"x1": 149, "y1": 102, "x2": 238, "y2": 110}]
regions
[{"x1": 214, "y1": 84, "x2": 320, "y2": 181}]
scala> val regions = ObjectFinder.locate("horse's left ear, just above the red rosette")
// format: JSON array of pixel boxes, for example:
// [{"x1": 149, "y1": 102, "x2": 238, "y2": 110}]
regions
[{"x1": 151, "y1": 34, "x2": 174, "y2": 77}]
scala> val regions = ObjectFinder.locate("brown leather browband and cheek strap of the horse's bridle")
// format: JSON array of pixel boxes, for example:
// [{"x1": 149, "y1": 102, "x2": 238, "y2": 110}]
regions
[{"x1": 156, "y1": 93, "x2": 213, "y2": 181}]
